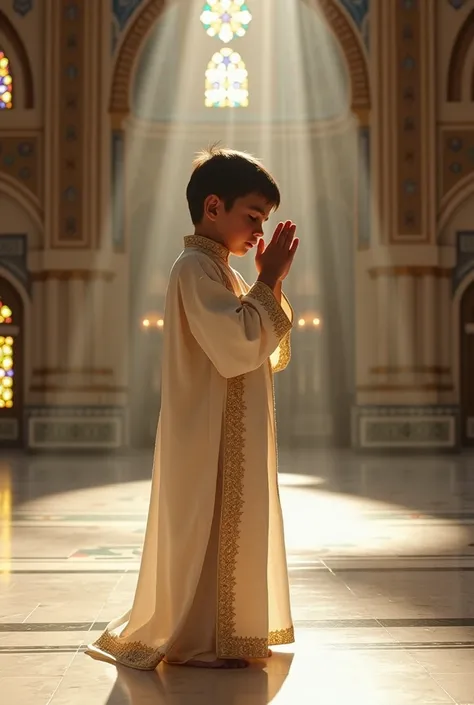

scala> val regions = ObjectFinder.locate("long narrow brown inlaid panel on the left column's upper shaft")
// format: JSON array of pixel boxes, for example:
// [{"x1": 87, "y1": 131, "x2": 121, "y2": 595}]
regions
[{"x1": 53, "y1": 0, "x2": 85, "y2": 247}]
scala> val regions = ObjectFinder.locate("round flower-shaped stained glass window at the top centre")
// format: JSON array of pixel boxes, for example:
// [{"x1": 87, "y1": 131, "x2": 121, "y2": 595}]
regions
[{"x1": 201, "y1": 0, "x2": 252, "y2": 44}]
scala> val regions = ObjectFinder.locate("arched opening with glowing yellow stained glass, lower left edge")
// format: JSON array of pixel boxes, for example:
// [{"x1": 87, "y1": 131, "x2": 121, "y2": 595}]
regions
[{"x1": 0, "y1": 277, "x2": 24, "y2": 448}]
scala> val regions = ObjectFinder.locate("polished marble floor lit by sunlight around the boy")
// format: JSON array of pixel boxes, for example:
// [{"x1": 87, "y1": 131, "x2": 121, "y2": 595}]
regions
[{"x1": 0, "y1": 451, "x2": 474, "y2": 705}]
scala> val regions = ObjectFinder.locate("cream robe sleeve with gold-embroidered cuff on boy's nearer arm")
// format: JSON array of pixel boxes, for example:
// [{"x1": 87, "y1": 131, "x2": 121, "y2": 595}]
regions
[{"x1": 178, "y1": 257, "x2": 292, "y2": 379}]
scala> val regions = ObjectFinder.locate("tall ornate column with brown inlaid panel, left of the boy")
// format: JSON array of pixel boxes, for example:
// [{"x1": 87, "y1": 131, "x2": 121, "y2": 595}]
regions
[{"x1": 28, "y1": 0, "x2": 128, "y2": 449}]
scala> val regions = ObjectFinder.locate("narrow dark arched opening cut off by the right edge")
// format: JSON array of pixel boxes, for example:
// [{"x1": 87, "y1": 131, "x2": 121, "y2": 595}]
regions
[{"x1": 460, "y1": 282, "x2": 474, "y2": 448}]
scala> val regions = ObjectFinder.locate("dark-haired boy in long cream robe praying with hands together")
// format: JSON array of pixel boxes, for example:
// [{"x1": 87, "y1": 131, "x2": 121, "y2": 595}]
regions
[{"x1": 87, "y1": 148, "x2": 298, "y2": 670}]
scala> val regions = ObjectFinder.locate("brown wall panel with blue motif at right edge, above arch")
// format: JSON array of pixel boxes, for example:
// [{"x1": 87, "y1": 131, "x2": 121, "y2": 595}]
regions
[{"x1": 441, "y1": 129, "x2": 474, "y2": 197}]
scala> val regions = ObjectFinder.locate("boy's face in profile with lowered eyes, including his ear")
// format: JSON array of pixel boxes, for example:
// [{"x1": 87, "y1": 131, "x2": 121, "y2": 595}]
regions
[{"x1": 204, "y1": 193, "x2": 273, "y2": 257}]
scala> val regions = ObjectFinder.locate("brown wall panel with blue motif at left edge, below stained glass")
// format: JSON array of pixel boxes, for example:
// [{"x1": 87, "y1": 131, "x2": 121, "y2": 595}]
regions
[{"x1": 0, "y1": 135, "x2": 40, "y2": 198}]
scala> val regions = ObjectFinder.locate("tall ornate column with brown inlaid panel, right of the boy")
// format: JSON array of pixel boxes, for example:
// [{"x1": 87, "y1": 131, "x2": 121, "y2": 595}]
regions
[{"x1": 354, "y1": 0, "x2": 456, "y2": 448}]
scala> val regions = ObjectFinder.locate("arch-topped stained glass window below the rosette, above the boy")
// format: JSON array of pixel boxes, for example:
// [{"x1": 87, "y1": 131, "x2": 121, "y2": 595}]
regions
[{"x1": 205, "y1": 48, "x2": 249, "y2": 108}]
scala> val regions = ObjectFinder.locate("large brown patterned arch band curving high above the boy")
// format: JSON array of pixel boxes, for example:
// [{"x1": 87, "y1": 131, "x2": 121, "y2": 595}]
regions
[{"x1": 109, "y1": 0, "x2": 370, "y2": 121}]
